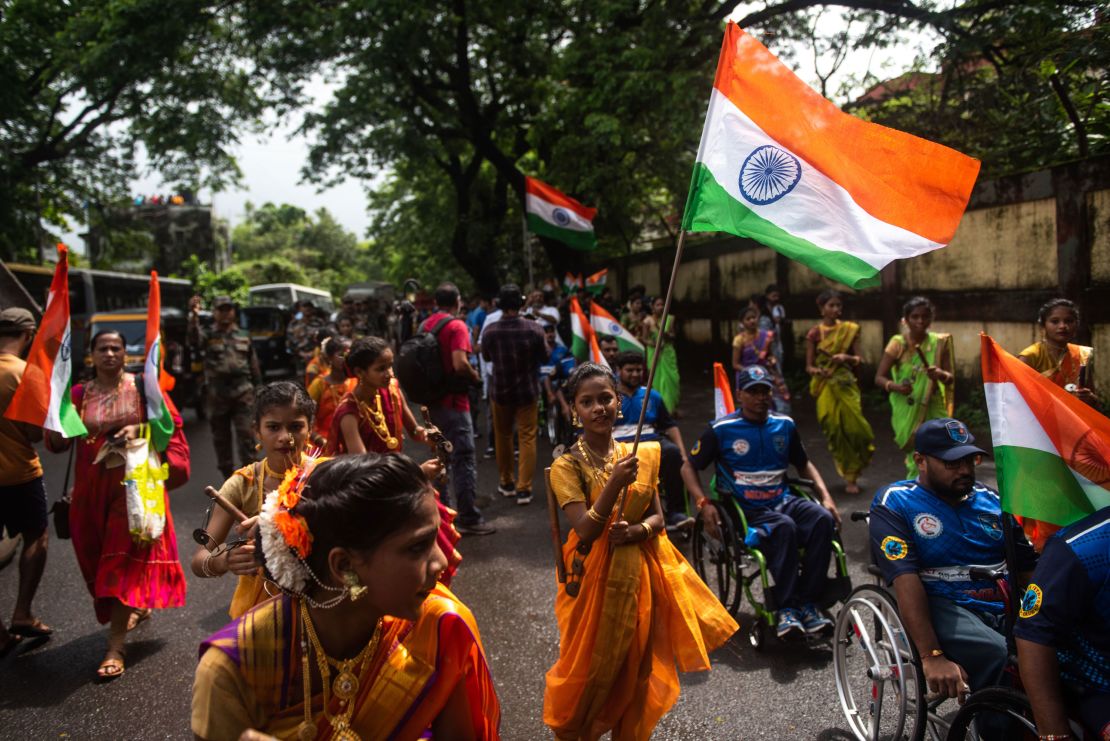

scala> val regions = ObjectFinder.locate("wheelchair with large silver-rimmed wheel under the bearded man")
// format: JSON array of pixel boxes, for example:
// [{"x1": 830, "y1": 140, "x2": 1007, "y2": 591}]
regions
[{"x1": 833, "y1": 511, "x2": 1083, "y2": 741}]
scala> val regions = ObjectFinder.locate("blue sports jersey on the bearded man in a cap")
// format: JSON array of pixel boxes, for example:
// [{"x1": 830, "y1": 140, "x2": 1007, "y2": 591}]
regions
[{"x1": 870, "y1": 480, "x2": 1037, "y2": 615}]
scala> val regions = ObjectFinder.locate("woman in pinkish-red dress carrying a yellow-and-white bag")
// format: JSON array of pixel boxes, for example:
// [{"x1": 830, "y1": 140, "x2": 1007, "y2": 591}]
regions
[{"x1": 48, "y1": 331, "x2": 189, "y2": 680}]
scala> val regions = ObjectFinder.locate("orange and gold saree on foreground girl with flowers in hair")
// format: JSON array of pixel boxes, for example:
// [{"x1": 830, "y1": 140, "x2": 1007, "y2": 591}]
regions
[{"x1": 192, "y1": 585, "x2": 501, "y2": 741}]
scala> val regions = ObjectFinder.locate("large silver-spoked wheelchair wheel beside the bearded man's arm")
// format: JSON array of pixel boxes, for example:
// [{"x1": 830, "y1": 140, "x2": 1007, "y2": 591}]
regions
[{"x1": 833, "y1": 585, "x2": 930, "y2": 741}]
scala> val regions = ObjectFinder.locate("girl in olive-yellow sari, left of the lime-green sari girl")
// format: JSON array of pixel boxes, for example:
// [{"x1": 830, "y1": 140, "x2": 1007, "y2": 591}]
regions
[{"x1": 806, "y1": 291, "x2": 875, "y2": 496}]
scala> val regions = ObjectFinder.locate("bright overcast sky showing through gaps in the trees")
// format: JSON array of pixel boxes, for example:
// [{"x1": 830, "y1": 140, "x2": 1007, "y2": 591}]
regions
[{"x1": 114, "y1": 10, "x2": 929, "y2": 251}]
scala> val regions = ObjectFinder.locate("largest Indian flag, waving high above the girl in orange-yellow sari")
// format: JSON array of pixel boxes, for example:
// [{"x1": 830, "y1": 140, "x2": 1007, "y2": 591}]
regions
[{"x1": 683, "y1": 22, "x2": 979, "y2": 288}]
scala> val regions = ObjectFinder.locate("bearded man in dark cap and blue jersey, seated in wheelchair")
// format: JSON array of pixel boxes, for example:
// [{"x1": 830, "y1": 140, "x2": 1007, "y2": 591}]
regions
[{"x1": 870, "y1": 418, "x2": 1037, "y2": 701}]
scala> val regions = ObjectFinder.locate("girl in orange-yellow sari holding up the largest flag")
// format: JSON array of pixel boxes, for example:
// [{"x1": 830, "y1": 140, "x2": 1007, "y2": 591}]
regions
[{"x1": 544, "y1": 363, "x2": 738, "y2": 741}]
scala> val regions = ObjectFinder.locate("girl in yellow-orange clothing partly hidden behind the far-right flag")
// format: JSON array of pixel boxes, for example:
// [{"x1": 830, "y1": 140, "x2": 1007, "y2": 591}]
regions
[{"x1": 1018, "y1": 298, "x2": 1099, "y2": 552}]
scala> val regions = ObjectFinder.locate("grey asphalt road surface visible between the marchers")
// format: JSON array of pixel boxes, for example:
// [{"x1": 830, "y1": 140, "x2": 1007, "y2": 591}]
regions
[{"x1": 0, "y1": 374, "x2": 993, "y2": 741}]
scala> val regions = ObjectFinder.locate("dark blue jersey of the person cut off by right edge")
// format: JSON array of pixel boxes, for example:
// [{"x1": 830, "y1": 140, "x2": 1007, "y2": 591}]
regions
[{"x1": 1013, "y1": 507, "x2": 1110, "y2": 693}]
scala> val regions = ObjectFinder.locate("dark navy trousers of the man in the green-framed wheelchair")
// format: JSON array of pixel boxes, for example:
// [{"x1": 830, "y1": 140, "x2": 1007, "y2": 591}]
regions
[{"x1": 741, "y1": 494, "x2": 836, "y2": 609}]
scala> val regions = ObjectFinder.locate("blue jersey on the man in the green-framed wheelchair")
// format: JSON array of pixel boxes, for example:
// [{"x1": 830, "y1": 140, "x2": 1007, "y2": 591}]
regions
[{"x1": 689, "y1": 412, "x2": 809, "y2": 508}]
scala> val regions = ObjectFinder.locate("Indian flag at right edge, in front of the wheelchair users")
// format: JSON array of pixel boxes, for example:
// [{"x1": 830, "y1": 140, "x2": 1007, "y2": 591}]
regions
[{"x1": 982, "y1": 335, "x2": 1110, "y2": 527}]
